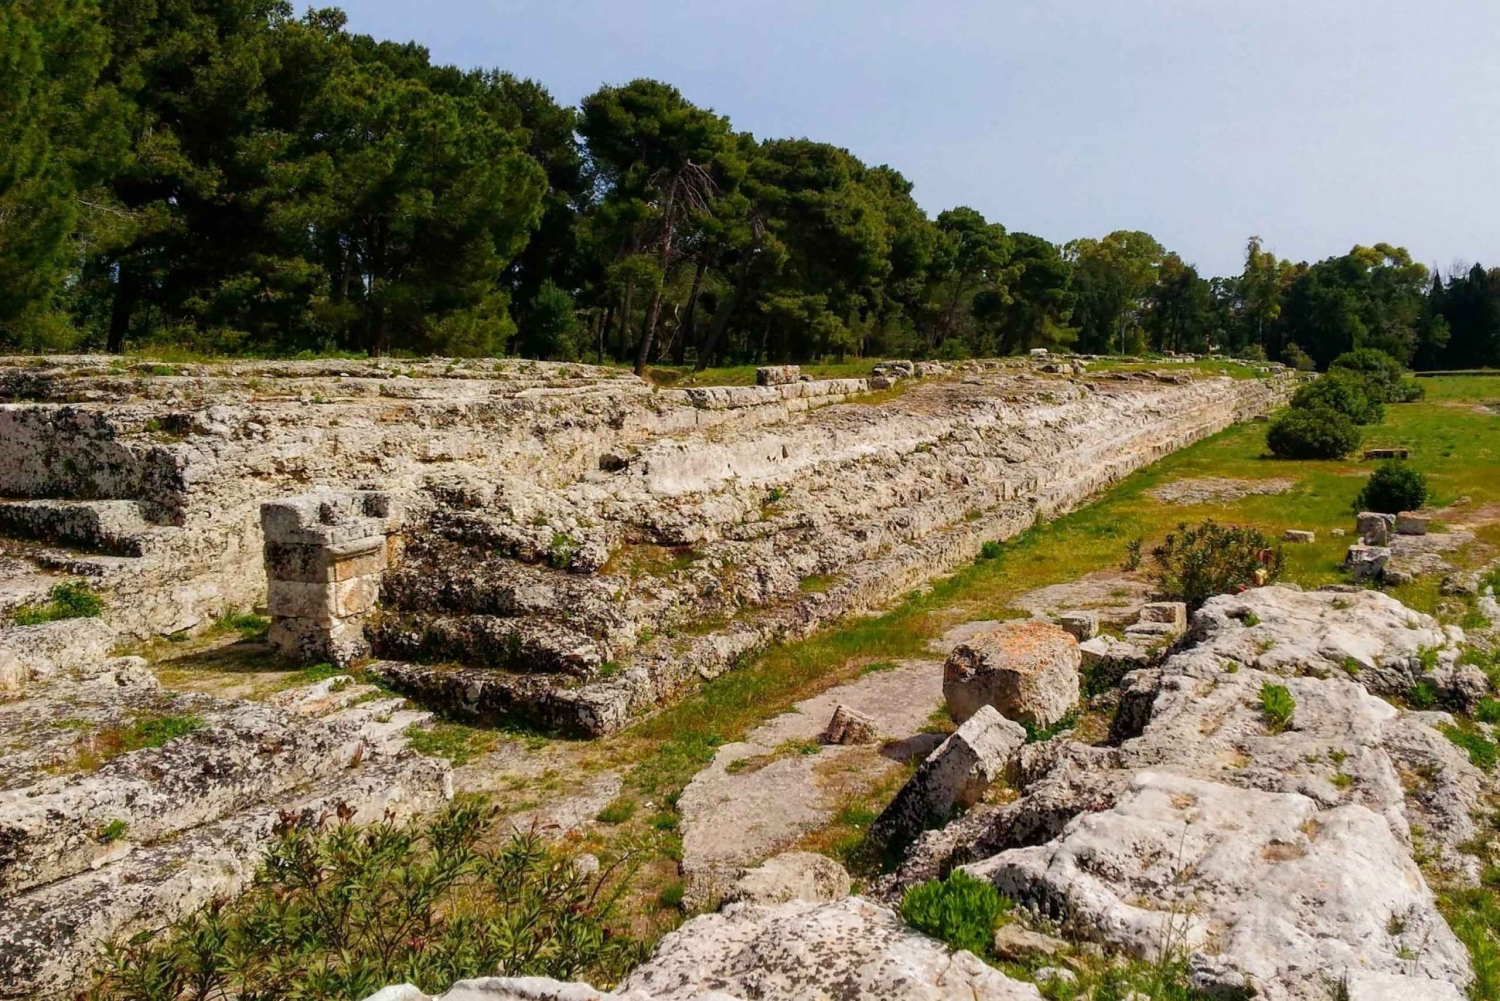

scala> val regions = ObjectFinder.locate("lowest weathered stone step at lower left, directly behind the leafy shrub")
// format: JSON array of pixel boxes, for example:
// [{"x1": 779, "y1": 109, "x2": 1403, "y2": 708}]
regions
[{"x1": 0, "y1": 756, "x2": 453, "y2": 999}]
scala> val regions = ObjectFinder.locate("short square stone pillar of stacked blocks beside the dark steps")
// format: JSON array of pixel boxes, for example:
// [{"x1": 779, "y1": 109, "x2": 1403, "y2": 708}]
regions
[{"x1": 261, "y1": 491, "x2": 402, "y2": 666}]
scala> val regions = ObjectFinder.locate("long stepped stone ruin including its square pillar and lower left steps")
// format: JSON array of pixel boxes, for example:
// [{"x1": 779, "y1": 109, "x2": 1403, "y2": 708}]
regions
[{"x1": 0, "y1": 357, "x2": 1293, "y2": 996}]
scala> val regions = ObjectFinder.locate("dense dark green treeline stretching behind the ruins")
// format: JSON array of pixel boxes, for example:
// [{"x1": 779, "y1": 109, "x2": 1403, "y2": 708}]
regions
[{"x1": 0, "y1": 0, "x2": 1500, "y2": 368}]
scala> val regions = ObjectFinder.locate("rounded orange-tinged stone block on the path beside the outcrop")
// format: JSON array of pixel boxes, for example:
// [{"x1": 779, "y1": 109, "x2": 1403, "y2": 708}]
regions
[{"x1": 942, "y1": 618, "x2": 1082, "y2": 726}]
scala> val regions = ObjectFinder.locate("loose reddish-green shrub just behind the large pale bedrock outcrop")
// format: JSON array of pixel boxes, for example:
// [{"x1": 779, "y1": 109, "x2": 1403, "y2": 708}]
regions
[{"x1": 1146, "y1": 519, "x2": 1281, "y2": 611}]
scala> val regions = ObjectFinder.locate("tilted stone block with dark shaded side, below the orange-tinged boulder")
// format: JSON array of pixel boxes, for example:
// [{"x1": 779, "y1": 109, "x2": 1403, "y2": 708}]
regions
[{"x1": 870, "y1": 705, "x2": 1026, "y2": 845}]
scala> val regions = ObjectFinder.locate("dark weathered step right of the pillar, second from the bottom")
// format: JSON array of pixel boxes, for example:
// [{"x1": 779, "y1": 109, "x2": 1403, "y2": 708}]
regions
[{"x1": 366, "y1": 614, "x2": 612, "y2": 678}]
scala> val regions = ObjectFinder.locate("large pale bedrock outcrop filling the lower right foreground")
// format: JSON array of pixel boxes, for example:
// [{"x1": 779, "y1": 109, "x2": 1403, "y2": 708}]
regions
[{"x1": 884, "y1": 587, "x2": 1490, "y2": 1001}]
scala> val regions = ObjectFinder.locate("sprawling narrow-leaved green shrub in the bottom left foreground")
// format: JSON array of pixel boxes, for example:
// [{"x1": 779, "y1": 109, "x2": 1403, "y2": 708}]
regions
[{"x1": 84, "y1": 800, "x2": 644, "y2": 1001}]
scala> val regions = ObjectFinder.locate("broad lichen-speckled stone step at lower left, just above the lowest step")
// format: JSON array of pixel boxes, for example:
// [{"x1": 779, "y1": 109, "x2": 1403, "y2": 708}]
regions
[{"x1": 0, "y1": 686, "x2": 363, "y2": 894}]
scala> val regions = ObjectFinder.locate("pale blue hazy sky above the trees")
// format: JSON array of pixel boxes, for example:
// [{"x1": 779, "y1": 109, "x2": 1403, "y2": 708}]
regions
[{"x1": 329, "y1": 0, "x2": 1500, "y2": 276}]
